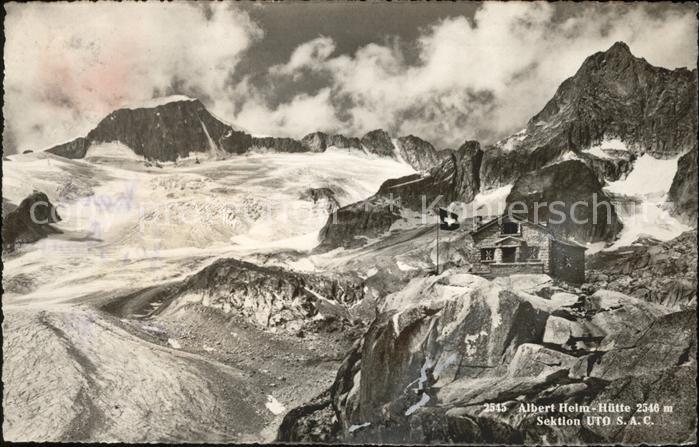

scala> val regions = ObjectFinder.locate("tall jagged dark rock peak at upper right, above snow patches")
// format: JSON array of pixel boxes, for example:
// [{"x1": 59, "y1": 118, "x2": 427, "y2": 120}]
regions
[{"x1": 527, "y1": 42, "x2": 697, "y2": 158}]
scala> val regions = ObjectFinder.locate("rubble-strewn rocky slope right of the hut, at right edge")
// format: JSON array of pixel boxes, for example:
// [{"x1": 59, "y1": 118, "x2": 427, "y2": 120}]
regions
[{"x1": 587, "y1": 231, "x2": 697, "y2": 310}]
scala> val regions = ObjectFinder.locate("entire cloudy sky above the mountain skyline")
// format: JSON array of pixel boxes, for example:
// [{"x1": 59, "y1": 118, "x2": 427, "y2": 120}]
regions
[{"x1": 3, "y1": 2, "x2": 697, "y2": 153}]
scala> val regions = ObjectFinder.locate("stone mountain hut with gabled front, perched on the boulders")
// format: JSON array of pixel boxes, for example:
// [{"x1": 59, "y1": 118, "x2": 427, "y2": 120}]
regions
[{"x1": 471, "y1": 214, "x2": 587, "y2": 284}]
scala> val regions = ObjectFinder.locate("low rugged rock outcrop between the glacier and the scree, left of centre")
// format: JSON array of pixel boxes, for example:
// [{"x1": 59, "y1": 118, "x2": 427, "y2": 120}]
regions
[{"x1": 159, "y1": 259, "x2": 364, "y2": 331}]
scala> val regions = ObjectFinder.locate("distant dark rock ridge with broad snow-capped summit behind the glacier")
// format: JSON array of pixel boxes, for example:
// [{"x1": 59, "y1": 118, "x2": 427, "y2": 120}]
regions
[{"x1": 48, "y1": 99, "x2": 446, "y2": 171}]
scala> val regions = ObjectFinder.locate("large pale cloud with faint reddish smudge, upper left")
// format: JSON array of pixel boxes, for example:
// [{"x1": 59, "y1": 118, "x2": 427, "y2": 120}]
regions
[{"x1": 3, "y1": 2, "x2": 263, "y2": 152}]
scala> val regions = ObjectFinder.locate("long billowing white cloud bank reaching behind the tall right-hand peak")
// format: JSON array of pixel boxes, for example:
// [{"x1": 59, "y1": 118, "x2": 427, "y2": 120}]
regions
[{"x1": 235, "y1": 2, "x2": 697, "y2": 147}]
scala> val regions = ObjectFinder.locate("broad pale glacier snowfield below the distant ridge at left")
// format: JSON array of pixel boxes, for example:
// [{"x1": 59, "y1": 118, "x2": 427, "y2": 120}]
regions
[{"x1": 3, "y1": 150, "x2": 412, "y2": 301}]
